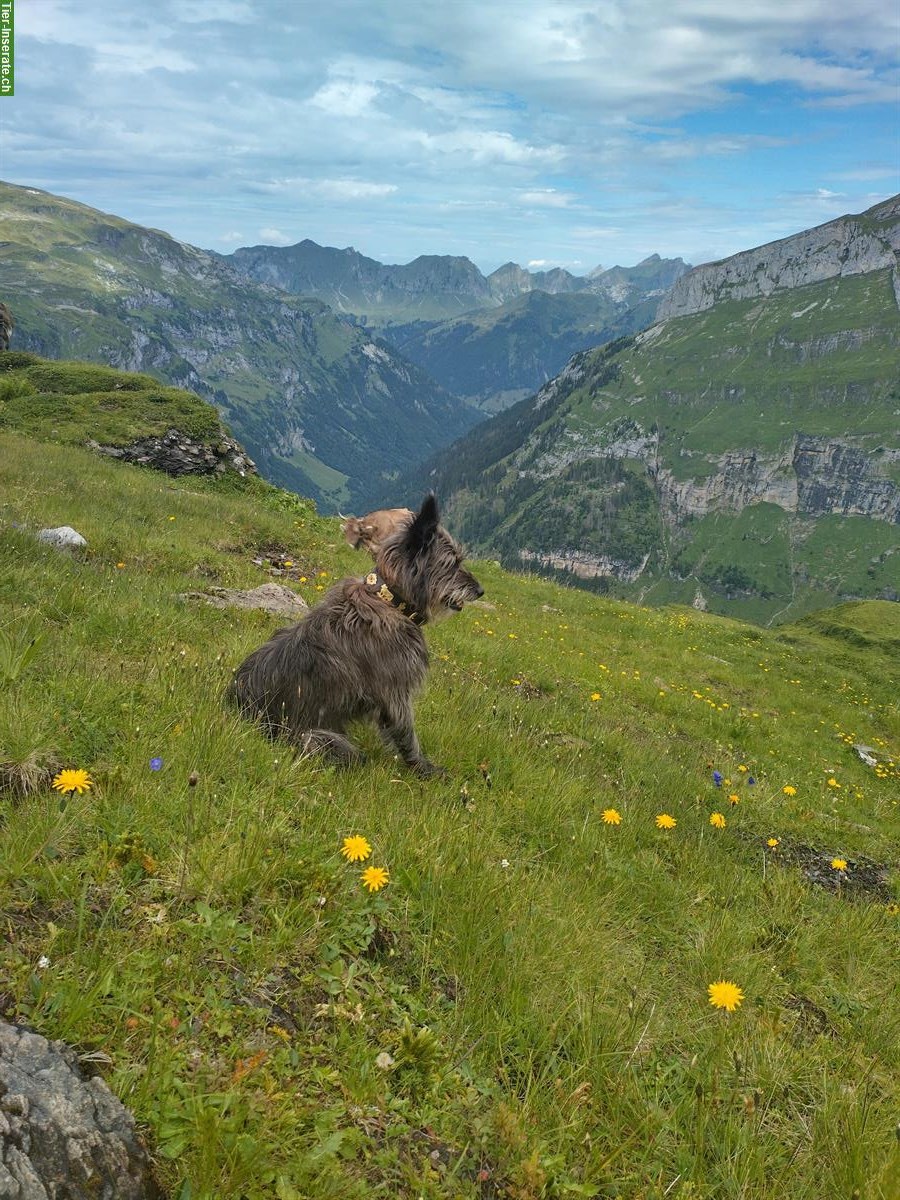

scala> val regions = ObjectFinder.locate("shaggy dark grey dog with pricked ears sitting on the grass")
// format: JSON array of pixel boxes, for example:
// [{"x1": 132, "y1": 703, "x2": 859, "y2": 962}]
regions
[{"x1": 229, "y1": 496, "x2": 484, "y2": 779}]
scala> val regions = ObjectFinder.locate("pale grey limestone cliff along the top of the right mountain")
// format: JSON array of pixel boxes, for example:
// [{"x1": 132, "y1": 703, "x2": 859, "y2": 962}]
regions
[{"x1": 656, "y1": 196, "x2": 900, "y2": 320}]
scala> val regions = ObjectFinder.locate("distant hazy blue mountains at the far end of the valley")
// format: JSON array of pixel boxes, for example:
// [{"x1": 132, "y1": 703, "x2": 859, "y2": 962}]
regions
[{"x1": 228, "y1": 239, "x2": 689, "y2": 413}]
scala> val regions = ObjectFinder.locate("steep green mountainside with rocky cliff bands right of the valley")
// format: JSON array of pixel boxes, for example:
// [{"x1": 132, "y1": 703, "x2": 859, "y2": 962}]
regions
[{"x1": 418, "y1": 192, "x2": 900, "y2": 622}]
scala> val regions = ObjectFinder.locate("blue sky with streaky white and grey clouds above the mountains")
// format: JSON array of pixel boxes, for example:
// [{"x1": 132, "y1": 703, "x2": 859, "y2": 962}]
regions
[{"x1": 7, "y1": 0, "x2": 900, "y2": 272}]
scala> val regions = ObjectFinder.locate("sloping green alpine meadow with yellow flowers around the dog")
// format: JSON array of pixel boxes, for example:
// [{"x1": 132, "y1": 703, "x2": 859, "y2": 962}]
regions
[{"x1": 0, "y1": 430, "x2": 900, "y2": 1200}]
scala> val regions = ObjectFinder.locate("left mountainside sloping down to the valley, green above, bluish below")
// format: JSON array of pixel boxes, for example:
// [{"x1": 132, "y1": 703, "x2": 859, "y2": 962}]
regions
[{"x1": 0, "y1": 184, "x2": 478, "y2": 511}]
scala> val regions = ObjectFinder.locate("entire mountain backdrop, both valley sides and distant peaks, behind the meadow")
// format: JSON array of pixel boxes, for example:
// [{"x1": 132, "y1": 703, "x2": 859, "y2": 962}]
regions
[{"x1": 0, "y1": 185, "x2": 900, "y2": 622}]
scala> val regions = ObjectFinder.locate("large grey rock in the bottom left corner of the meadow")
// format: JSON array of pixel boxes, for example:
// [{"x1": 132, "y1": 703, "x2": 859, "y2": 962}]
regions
[{"x1": 0, "y1": 1021, "x2": 163, "y2": 1200}]
